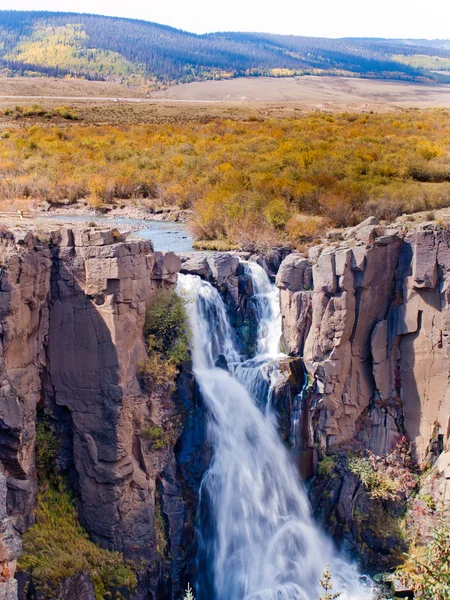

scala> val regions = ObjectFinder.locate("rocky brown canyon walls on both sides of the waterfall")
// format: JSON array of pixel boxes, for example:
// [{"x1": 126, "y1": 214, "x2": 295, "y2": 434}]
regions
[{"x1": 0, "y1": 218, "x2": 450, "y2": 600}]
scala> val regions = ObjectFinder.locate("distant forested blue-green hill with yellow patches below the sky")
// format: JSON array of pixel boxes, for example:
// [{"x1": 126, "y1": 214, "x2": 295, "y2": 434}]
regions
[{"x1": 0, "y1": 11, "x2": 450, "y2": 89}]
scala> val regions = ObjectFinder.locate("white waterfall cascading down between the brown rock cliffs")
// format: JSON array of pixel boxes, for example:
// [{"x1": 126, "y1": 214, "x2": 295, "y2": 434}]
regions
[{"x1": 177, "y1": 265, "x2": 372, "y2": 600}]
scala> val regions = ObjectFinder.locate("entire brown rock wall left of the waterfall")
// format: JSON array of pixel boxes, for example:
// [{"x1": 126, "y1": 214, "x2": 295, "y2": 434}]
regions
[{"x1": 0, "y1": 228, "x2": 203, "y2": 599}]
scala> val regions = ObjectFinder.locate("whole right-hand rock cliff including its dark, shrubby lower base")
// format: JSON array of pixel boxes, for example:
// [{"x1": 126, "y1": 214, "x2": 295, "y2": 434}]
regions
[{"x1": 276, "y1": 220, "x2": 450, "y2": 571}]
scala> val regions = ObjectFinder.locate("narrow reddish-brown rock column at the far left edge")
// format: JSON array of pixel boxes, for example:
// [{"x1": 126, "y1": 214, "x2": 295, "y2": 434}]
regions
[{"x1": 0, "y1": 234, "x2": 52, "y2": 531}]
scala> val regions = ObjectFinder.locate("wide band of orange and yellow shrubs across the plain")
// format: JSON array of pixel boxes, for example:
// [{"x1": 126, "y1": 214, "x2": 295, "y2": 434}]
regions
[{"x1": 0, "y1": 110, "x2": 450, "y2": 246}]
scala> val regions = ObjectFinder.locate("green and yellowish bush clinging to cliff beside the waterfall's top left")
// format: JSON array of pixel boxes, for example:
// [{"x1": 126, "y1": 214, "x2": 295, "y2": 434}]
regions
[{"x1": 138, "y1": 290, "x2": 189, "y2": 388}]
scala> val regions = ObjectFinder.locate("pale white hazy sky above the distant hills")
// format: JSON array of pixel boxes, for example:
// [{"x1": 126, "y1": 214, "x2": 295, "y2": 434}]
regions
[{"x1": 0, "y1": 0, "x2": 450, "y2": 39}]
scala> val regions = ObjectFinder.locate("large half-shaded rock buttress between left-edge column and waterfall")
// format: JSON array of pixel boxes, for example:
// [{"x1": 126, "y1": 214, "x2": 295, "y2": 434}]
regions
[{"x1": 44, "y1": 230, "x2": 179, "y2": 558}]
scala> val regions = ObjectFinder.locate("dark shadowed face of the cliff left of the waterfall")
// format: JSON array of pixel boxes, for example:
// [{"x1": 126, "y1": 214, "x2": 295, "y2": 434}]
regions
[{"x1": 43, "y1": 243, "x2": 124, "y2": 550}]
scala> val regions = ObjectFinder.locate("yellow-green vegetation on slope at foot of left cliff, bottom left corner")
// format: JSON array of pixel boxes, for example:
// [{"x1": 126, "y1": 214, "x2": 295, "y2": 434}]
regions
[{"x1": 18, "y1": 478, "x2": 137, "y2": 600}]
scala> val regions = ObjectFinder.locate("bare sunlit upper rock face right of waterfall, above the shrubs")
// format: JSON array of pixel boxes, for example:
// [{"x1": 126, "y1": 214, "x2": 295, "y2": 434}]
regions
[{"x1": 277, "y1": 224, "x2": 450, "y2": 460}]
